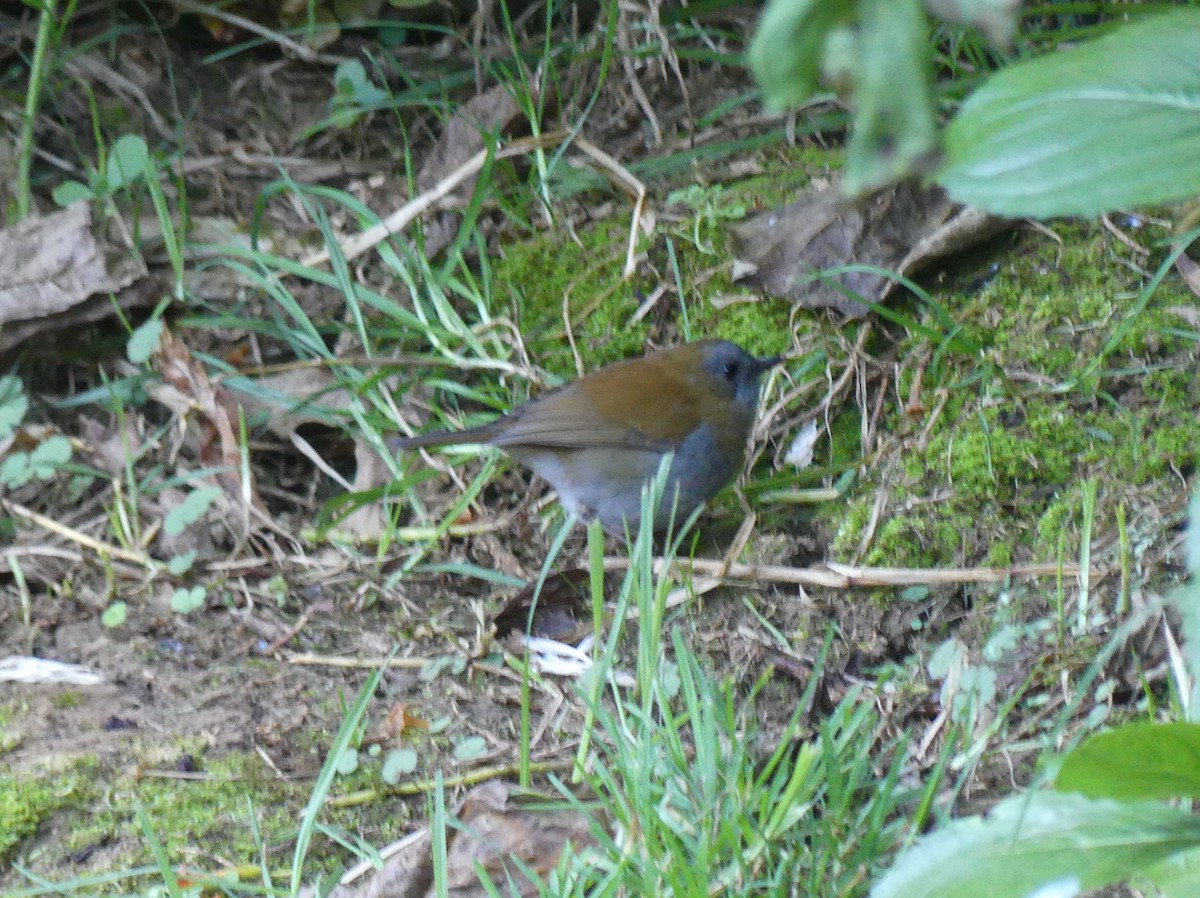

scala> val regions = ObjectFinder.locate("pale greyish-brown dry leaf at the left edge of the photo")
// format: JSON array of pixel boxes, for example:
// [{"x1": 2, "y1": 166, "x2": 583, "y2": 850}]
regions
[{"x1": 0, "y1": 200, "x2": 151, "y2": 352}]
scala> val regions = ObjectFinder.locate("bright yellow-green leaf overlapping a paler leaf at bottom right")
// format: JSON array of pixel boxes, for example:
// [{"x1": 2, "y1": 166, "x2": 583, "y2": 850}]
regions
[{"x1": 1055, "y1": 723, "x2": 1200, "y2": 801}]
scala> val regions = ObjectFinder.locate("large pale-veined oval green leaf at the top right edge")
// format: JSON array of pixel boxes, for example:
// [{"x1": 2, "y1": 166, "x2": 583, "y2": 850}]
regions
[{"x1": 936, "y1": 8, "x2": 1200, "y2": 217}]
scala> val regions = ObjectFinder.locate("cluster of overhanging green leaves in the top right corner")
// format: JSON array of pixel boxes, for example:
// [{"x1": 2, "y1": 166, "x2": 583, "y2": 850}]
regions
[{"x1": 750, "y1": 0, "x2": 1200, "y2": 217}]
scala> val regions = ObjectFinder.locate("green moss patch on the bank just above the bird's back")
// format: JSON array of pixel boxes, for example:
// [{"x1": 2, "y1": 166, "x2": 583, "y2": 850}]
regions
[{"x1": 491, "y1": 148, "x2": 835, "y2": 378}]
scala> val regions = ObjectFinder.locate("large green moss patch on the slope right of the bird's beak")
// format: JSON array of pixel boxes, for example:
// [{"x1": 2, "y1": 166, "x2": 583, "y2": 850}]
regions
[{"x1": 830, "y1": 216, "x2": 1200, "y2": 576}]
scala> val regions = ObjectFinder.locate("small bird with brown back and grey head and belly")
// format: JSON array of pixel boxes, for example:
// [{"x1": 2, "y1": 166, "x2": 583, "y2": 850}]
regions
[{"x1": 386, "y1": 340, "x2": 782, "y2": 535}]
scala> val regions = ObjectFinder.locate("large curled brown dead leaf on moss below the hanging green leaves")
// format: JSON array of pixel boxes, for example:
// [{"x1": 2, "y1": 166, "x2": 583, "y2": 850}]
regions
[{"x1": 732, "y1": 182, "x2": 1008, "y2": 317}]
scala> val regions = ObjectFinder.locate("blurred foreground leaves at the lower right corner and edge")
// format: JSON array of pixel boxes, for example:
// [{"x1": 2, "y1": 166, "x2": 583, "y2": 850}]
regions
[{"x1": 871, "y1": 493, "x2": 1200, "y2": 898}]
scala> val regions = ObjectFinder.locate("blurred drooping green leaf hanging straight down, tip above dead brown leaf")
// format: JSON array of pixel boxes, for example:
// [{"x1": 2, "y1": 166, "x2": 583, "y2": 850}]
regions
[{"x1": 841, "y1": 0, "x2": 937, "y2": 197}]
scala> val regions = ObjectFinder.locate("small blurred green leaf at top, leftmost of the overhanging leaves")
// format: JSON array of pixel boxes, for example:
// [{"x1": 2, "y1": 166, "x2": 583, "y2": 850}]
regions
[{"x1": 749, "y1": 0, "x2": 854, "y2": 109}]
